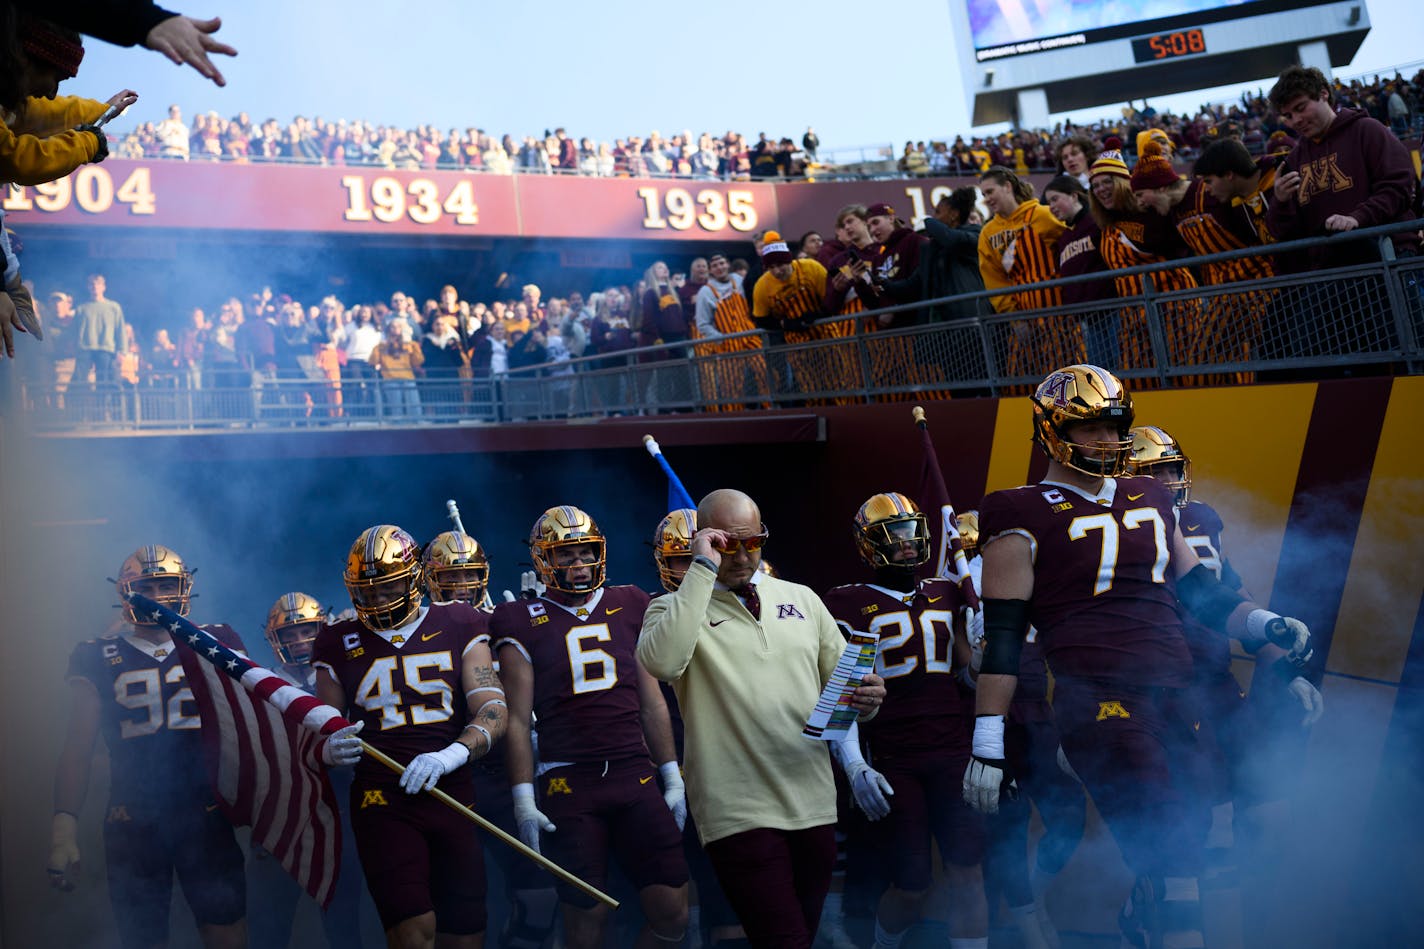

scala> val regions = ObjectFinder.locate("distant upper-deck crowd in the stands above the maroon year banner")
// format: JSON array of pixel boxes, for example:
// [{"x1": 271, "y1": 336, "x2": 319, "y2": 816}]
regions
[{"x1": 103, "y1": 70, "x2": 1424, "y2": 178}]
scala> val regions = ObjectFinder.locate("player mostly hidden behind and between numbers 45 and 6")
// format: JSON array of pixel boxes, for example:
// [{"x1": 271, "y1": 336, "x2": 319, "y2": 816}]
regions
[{"x1": 422, "y1": 530, "x2": 558, "y2": 949}]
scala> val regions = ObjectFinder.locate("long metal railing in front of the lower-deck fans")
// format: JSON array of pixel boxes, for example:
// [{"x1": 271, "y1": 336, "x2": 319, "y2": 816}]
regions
[{"x1": 20, "y1": 221, "x2": 1424, "y2": 432}]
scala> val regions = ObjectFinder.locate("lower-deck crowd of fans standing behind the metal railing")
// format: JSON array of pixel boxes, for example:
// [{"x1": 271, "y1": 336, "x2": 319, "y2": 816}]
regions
[{"x1": 31, "y1": 61, "x2": 1420, "y2": 416}]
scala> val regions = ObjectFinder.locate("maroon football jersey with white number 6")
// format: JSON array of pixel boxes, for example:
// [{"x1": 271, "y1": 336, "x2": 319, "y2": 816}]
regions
[{"x1": 490, "y1": 586, "x2": 648, "y2": 764}]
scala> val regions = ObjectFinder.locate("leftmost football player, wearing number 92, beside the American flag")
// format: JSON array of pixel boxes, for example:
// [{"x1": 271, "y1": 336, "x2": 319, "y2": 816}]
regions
[{"x1": 48, "y1": 544, "x2": 248, "y2": 949}]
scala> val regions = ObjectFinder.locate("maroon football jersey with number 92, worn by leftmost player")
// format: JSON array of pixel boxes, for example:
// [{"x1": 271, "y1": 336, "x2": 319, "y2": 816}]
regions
[{"x1": 68, "y1": 624, "x2": 246, "y2": 803}]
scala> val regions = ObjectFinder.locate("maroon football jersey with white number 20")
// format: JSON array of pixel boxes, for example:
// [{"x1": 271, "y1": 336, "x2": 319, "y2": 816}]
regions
[{"x1": 823, "y1": 580, "x2": 974, "y2": 754}]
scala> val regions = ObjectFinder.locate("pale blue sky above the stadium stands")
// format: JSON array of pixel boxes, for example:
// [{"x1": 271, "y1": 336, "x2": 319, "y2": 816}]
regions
[{"x1": 75, "y1": 0, "x2": 1424, "y2": 158}]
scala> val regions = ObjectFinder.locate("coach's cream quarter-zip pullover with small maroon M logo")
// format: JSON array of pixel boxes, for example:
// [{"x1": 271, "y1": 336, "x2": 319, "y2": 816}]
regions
[{"x1": 638, "y1": 563, "x2": 846, "y2": 844}]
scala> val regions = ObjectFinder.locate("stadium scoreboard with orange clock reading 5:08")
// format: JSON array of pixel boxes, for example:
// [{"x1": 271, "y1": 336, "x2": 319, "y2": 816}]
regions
[{"x1": 950, "y1": 0, "x2": 1370, "y2": 128}]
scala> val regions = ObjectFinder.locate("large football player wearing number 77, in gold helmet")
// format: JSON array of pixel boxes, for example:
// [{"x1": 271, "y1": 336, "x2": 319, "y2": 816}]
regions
[{"x1": 964, "y1": 363, "x2": 1312, "y2": 945}]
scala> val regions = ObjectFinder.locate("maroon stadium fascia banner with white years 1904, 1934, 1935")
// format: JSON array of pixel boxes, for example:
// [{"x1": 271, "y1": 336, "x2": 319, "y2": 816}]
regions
[{"x1": 4, "y1": 158, "x2": 1047, "y2": 241}]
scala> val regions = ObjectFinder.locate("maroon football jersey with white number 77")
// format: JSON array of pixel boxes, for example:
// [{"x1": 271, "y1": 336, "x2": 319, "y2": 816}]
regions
[{"x1": 980, "y1": 477, "x2": 1192, "y2": 685}]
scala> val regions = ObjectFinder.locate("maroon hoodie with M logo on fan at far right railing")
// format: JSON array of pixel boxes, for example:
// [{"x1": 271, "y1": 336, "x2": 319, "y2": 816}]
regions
[{"x1": 1266, "y1": 108, "x2": 1420, "y2": 266}]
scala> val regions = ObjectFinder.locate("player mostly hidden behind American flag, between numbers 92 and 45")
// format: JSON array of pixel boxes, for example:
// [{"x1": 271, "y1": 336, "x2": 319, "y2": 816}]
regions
[{"x1": 248, "y1": 590, "x2": 373, "y2": 949}]
